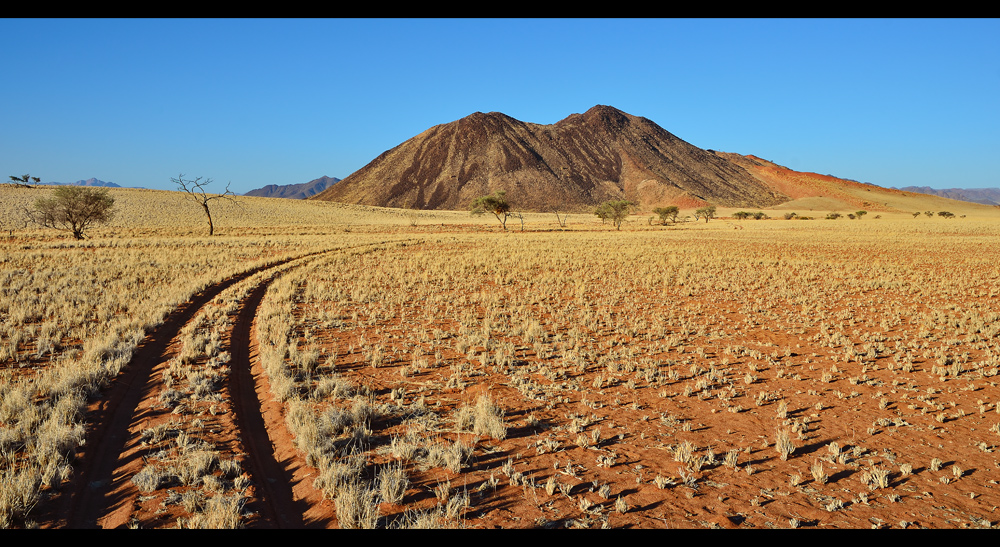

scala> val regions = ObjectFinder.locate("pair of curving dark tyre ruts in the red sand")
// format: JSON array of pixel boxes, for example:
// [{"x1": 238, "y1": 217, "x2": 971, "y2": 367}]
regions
[{"x1": 47, "y1": 249, "x2": 334, "y2": 528}]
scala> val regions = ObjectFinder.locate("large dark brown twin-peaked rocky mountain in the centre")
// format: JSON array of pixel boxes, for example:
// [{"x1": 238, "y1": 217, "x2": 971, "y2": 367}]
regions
[{"x1": 312, "y1": 105, "x2": 789, "y2": 211}]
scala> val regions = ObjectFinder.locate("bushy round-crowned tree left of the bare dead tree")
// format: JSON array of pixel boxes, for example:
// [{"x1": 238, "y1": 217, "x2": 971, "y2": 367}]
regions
[{"x1": 28, "y1": 186, "x2": 115, "y2": 239}]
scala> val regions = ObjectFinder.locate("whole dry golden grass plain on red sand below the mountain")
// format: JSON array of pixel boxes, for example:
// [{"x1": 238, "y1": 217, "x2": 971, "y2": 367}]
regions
[{"x1": 0, "y1": 187, "x2": 1000, "y2": 528}]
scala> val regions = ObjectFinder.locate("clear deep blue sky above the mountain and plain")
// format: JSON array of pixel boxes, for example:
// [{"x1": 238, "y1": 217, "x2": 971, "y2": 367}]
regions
[{"x1": 0, "y1": 19, "x2": 1000, "y2": 193}]
